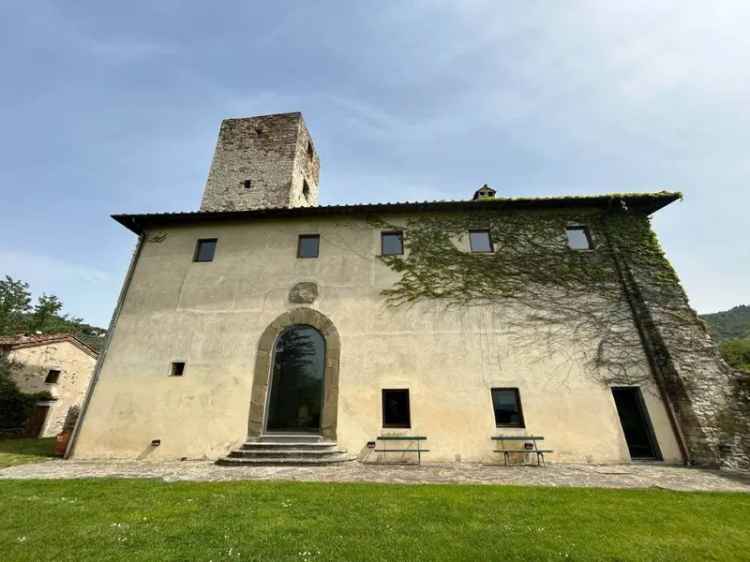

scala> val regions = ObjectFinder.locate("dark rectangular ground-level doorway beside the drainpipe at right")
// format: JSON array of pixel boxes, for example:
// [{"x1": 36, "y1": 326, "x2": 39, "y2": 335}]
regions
[{"x1": 612, "y1": 386, "x2": 661, "y2": 460}]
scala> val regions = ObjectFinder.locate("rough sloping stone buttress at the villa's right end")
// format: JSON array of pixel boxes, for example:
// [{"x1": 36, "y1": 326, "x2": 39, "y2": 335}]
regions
[{"x1": 612, "y1": 214, "x2": 746, "y2": 466}]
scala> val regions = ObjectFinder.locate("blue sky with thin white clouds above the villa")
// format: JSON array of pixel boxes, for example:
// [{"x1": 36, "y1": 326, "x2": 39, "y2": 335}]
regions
[{"x1": 0, "y1": 0, "x2": 750, "y2": 326}]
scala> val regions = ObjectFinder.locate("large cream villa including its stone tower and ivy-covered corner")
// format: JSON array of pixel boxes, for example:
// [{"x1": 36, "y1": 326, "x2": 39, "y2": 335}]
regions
[{"x1": 68, "y1": 113, "x2": 746, "y2": 465}]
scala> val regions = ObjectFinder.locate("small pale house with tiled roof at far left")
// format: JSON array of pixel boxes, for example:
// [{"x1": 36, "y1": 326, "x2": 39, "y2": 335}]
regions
[{"x1": 0, "y1": 334, "x2": 97, "y2": 437}]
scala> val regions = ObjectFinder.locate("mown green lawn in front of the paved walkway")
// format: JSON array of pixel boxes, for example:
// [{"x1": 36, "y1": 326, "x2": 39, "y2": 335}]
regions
[{"x1": 0, "y1": 480, "x2": 750, "y2": 561}]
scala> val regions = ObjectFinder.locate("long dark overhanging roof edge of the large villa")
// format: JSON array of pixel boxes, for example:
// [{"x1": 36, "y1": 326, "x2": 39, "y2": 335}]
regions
[{"x1": 112, "y1": 191, "x2": 682, "y2": 234}]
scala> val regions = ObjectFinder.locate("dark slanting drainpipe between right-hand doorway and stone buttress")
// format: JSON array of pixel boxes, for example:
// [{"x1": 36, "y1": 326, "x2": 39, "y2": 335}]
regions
[{"x1": 604, "y1": 213, "x2": 693, "y2": 466}]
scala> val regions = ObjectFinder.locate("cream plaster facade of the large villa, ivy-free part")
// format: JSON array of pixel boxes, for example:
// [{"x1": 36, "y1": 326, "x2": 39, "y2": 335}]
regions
[{"x1": 74, "y1": 212, "x2": 681, "y2": 463}]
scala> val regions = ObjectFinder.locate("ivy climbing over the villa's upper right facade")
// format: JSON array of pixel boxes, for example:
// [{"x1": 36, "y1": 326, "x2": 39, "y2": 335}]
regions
[{"x1": 370, "y1": 202, "x2": 679, "y2": 384}]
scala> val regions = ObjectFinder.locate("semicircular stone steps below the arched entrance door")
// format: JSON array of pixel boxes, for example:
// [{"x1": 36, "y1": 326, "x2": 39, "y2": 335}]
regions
[{"x1": 216, "y1": 433, "x2": 353, "y2": 466}]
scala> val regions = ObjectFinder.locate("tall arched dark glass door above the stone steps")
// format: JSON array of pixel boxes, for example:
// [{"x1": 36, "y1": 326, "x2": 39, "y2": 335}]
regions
[{"x1": 266, "y1": 324, "x2": 325, "y2": 433}]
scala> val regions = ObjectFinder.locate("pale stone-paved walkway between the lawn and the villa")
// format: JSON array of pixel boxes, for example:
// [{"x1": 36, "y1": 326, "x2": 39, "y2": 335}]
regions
[{"x1": 0, "y1": 460, "x2": 750, "y2": 492}]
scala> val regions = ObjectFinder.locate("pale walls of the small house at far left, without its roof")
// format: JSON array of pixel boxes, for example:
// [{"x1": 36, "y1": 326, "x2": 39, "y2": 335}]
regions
[{"x1": 8, "y1": 341, "x2": 96, "y2": 437}]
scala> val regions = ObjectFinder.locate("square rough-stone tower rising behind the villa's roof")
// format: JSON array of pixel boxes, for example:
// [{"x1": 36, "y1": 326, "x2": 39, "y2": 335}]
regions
[{"x1": 201, "y1": 112, "x2": 320, "y2": 211}]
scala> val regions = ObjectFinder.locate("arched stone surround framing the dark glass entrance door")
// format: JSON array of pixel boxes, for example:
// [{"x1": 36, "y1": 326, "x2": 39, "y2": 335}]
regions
[{"x1": 248, "y1": 308, "x2": 341, "y2": 440}]
